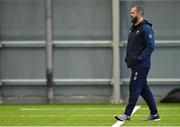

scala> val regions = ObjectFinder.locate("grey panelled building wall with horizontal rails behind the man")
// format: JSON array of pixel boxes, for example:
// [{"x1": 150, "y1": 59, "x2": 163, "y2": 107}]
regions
[{"x1": 0, "y1": 0, "x2": 180, "y2": 103}]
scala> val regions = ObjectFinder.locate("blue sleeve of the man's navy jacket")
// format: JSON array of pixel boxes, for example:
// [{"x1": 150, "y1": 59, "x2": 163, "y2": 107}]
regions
[{"x1": 138, "y1": 25, "x2": 155, "y2": 60}]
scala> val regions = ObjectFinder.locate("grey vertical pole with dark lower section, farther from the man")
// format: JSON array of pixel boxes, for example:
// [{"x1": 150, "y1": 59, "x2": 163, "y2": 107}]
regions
[{"x1": 45, "y1": 0, "x2": 54, "y2": 104}]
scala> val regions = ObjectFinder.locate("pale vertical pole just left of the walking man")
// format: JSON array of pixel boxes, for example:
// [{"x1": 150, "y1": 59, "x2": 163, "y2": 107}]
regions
[{"x1": 112, "y1": 0, "x2": 120, "y2": 104}]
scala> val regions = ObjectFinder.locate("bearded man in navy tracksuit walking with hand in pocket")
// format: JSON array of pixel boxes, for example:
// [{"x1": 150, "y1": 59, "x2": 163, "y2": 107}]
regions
[{"x1": 115, "y1": 6, "x2": 160, "y2": 121}]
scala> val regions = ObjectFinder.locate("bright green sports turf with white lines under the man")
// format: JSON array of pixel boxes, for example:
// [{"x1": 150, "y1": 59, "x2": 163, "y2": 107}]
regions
[{"x1": 0, "y1": 104, "x2": 180, "y2": 127}]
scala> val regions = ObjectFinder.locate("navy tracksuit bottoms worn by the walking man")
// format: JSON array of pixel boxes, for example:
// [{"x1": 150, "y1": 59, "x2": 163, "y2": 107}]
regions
[{"x1": 124, "y1": 66, "x2": 158, "y2": 116}]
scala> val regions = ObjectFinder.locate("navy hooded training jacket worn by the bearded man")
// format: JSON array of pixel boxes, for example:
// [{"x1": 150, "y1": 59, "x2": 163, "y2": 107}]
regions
[{"x1": 125, "y1": 20, "x2": 155, "y2": 68}]
